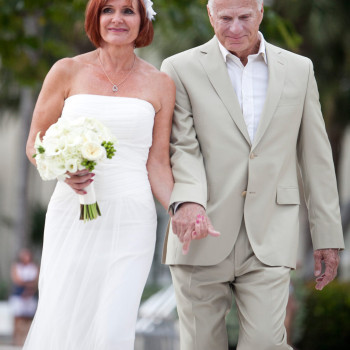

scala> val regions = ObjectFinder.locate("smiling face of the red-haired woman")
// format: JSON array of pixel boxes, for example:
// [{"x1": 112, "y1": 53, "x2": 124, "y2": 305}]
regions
[{"x1": 100, "y1": 0, "x2": 141, "y2": 46}]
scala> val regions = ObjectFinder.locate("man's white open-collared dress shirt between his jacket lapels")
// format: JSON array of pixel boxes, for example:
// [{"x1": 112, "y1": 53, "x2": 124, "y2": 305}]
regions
[{"x1": 218, "y1": 32, "x2": 268, "y2": 142}]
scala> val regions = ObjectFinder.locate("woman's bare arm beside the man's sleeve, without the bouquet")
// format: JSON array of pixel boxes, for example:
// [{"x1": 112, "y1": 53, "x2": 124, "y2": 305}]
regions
[{"x1": 147, "y1": 73, "x2": 175, "y2": 210}]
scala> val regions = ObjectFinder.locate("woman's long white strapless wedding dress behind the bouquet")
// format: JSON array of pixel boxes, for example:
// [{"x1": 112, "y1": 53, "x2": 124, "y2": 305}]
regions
[{"x1": 23, "y1": 94, "x2": 157, "y2": 350}]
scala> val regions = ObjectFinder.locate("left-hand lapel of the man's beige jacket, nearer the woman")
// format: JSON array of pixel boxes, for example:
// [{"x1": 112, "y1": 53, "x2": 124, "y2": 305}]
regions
[{"x1": 199, "y1": 37, "x2": 251, "y2": 144}]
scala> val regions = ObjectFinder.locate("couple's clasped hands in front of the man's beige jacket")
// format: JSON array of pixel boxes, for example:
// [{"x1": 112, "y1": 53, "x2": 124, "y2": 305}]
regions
[{"x1": 172, "y1": 203, "x2": 220, "y2": 254}]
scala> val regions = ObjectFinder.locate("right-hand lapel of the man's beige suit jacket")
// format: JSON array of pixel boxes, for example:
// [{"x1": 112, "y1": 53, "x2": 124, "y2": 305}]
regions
[{"x1": 252, "y1": 43, "x2": 286, "y2": 149}]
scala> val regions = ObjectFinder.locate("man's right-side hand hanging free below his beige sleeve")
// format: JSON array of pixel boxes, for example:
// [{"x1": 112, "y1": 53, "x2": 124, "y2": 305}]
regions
[{"x1": 314, "y1": 249, "x2": 339, "y2": 290}]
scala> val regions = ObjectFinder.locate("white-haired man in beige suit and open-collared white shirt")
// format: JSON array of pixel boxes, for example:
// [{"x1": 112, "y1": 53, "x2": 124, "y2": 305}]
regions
[{"x1": 162, "y1": 0, "x2": 344, "y2": 350}]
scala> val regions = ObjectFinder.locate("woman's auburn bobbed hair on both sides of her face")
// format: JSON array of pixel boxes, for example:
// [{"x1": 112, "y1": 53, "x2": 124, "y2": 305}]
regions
[{"x1": 85, "y1": 0, "x2": 154, "y2": 48}]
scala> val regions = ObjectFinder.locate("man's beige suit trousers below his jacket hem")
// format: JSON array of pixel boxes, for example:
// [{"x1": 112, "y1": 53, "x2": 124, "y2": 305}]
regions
[{"x1": 170, "y1": 222, "x2": 292, "y2": 350}]
